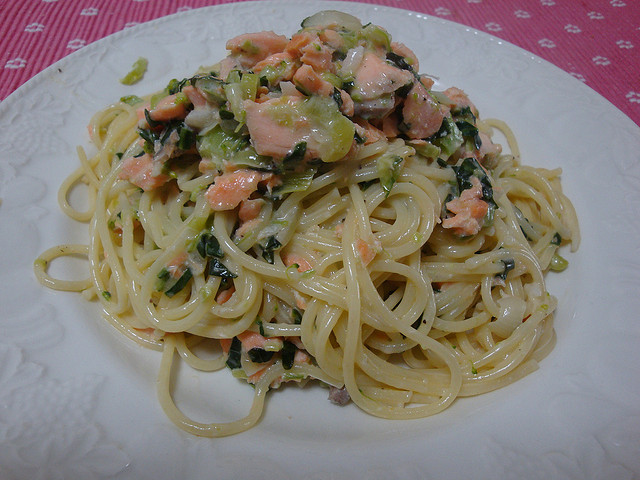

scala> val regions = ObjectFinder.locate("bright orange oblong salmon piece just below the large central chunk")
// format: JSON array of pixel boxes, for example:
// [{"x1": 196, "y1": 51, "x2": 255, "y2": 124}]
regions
[{"x1": 205, "y1": 168, "x2": 273, "y2": 211}]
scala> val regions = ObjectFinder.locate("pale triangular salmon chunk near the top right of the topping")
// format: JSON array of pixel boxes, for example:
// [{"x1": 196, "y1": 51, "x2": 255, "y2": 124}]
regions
[{"x1": 351, "y1": 52, "x2": 413, "y2": 101}]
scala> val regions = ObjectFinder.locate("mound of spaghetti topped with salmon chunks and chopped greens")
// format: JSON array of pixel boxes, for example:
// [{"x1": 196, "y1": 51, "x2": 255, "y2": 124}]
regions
[{"x1": 34, "y1": 11, "x2": 579, "y2": 437}]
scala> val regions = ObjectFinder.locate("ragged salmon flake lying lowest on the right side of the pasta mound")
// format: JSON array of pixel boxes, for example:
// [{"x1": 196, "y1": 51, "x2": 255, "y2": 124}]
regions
[{"x1": 442, "y1": 177, "x2": 489, "y2": 236}]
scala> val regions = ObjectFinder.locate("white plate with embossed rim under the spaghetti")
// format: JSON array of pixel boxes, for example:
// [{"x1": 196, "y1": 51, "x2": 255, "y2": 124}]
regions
[{"x1": 0, "y1": 1, "x2": 640, "y2": 479}]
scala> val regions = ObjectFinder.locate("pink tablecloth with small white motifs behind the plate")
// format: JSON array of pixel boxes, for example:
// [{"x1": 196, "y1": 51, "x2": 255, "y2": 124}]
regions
[{"x1": 0, "y1": 0, "x2": 640, "y2": 125}]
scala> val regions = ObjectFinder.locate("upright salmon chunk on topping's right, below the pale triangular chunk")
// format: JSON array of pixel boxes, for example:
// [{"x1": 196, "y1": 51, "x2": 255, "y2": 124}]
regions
[{"x1": 402, "y1": 82, "x2": 446, "y2": 138}]
